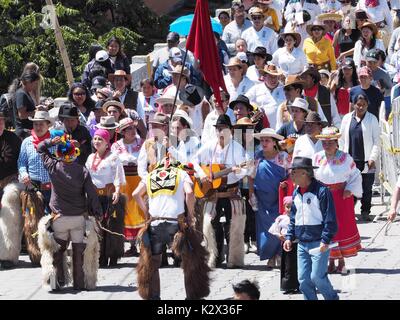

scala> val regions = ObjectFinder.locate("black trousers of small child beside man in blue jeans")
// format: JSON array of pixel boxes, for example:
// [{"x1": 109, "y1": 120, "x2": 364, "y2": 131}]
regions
[{"x1": 281, "y1": 243, "x2": 299, "y2": 291}]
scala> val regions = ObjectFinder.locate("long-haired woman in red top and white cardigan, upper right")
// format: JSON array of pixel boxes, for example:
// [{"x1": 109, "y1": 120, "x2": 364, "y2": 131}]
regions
[{"x1": 330, "y1": 58, "x2": 359, "y2": 117}]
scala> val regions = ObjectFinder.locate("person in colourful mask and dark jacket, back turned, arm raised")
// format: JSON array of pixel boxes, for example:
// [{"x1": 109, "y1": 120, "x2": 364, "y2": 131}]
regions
[{"x1": 38, "y1": 136, "x2": 103, "y2": 290}]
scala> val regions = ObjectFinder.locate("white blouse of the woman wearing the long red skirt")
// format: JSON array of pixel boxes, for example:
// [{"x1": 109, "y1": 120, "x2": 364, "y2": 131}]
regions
[{"x1": 314, "y1": 150, "x2": 363, "y2": 198}]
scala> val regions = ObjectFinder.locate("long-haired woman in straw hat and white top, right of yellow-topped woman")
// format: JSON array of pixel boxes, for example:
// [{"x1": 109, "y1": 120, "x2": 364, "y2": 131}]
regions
[{"x1": 353, "y1": 22, "x2": 386, "y2": 67}]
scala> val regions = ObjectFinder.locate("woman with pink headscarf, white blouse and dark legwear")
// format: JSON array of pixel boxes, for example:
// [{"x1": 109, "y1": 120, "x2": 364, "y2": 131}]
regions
[{"x1": 86, "y1": 129, "x2": 126, "y2": 267}]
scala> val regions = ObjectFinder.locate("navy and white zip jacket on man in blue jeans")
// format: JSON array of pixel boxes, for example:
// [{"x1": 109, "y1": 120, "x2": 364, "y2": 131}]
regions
[{"x1": 286, "y1": 179, "x2": 338, "y2": 244}]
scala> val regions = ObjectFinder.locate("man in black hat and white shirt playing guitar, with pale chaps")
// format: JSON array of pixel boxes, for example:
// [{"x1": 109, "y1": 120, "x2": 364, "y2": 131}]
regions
[{"x1": 193, "y1": 115, "x2": 252, "y2": 268}]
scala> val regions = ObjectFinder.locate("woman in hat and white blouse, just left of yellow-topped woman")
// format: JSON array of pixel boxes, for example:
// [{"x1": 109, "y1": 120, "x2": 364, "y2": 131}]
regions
[{"x1": 272, "y1": 23, "x2": 307, "y2": 77}]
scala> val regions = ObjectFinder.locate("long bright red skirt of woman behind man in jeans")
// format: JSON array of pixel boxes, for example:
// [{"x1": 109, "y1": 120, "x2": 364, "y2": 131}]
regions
[{"x1": 330, "y1": 189, "x2": 362, "y2": 259}]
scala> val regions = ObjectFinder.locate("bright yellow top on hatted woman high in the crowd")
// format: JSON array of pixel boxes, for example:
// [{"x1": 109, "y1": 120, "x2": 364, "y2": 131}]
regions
[{"x1": 303, "y1": 37, "x2": 337, "y2": 71}]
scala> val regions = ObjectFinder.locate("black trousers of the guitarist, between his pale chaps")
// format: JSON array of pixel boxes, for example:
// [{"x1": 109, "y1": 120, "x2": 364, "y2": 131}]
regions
[{"x1": 211, "y1": 198, "x2": 232, "y2": 266}]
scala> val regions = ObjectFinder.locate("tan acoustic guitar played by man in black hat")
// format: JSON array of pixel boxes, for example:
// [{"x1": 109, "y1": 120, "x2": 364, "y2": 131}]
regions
[{"x1": 194, "y1": 161, "x2": 252, "y2": 199}]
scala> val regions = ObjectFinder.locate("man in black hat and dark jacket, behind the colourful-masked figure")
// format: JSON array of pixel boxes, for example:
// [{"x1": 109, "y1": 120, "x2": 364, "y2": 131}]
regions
[{"x1": 58, "y1": 103, "x2": 92, "y2": 166}]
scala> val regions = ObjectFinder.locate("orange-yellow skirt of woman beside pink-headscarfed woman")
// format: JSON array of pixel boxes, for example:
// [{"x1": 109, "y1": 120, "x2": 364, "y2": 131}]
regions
[{"x1": 121, "y1": 176, "x2": 145, "y2": 240}]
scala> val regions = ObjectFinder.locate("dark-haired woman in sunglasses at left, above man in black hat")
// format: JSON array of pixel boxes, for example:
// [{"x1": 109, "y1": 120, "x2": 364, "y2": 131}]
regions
[{"x1": 68, "y1": 82, "x2": 95, "y2": 126}]
